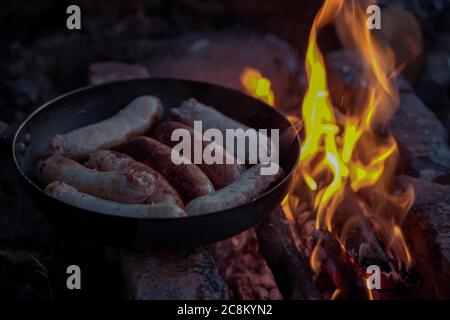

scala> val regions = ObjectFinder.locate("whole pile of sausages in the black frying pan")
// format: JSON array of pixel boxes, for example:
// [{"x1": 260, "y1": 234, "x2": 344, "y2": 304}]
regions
[{"x1": 36, "y1": 96, "x2": 283, "y2": 218}]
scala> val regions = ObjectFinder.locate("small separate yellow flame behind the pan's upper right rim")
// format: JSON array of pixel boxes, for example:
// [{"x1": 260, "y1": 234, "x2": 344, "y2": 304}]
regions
[{"x1": 240, "y1": 68, "x2": 275, "y2": 106}]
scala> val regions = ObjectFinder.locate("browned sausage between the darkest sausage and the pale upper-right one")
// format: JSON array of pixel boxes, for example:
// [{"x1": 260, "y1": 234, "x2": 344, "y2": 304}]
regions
[{"x1": 153, "y1": 121, "x2": 245, "y2": 189}]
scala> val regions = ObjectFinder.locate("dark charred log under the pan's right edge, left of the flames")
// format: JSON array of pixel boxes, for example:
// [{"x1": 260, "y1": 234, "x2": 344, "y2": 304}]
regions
[{"x1": 256, "y1": 208, "x2": 321, "y2": 300}]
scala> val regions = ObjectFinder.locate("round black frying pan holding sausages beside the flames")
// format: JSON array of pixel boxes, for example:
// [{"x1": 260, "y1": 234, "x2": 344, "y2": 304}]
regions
[{"x1": 7, "y1": 79, "x2": 300, "y2": 251}]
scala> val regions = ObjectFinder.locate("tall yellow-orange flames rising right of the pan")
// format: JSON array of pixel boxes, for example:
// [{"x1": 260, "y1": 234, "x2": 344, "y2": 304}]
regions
[{"x1": 299, "y1": 0, "x2": 411, "y2": 272}]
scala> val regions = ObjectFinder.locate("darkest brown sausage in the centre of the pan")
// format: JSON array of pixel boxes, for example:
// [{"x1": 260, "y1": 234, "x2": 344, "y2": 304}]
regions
[{"x1": 120, "y1": 137, "x2": 214, "y2": 202}]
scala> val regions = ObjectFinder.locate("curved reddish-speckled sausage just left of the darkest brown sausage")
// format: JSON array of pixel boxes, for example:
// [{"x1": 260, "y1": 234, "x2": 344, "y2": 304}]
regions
[{"x1": 85, "y1": 150, "x2": 184, "y2": 208}]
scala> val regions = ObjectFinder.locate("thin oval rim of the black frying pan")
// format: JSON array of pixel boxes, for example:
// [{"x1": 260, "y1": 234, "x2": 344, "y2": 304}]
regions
[{"x1": 12, "y1": 77, "x2": 301, "y2": 222}]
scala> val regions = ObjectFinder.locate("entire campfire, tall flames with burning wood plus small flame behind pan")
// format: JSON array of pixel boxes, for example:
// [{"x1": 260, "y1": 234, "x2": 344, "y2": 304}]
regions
[{"x1": 241, "y1": 0, "x2": 420, "y2": 299}]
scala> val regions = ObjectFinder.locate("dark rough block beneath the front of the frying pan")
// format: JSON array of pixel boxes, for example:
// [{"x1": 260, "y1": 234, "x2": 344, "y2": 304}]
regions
[{"x1": 121, "y1": 248, "x2": 228, "y2": 300}]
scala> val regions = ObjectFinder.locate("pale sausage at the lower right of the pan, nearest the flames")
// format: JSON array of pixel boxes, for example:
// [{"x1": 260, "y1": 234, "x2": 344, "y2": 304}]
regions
[{"x1": 186, "y1": 163, "x2": 284, "y2": 216}]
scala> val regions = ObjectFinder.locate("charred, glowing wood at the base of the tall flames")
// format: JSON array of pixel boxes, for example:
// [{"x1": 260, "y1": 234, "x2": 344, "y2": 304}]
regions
[{"x1": 296, "y1": 201, "x2": 412, "y2": 300}]
